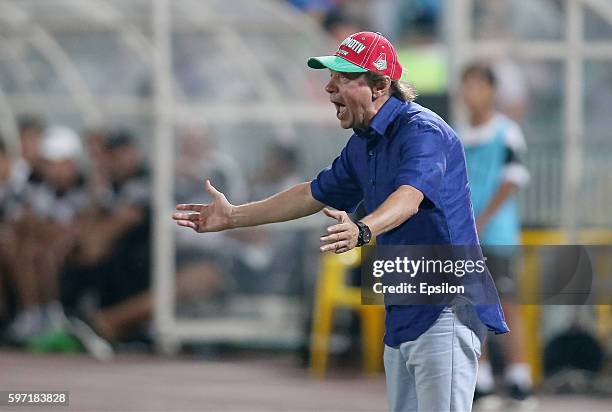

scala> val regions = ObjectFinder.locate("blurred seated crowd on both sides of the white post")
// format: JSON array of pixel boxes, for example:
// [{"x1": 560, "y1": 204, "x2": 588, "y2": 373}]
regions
[{"x1": 0, "y1": 115, "x2": 300, "y2": 357}]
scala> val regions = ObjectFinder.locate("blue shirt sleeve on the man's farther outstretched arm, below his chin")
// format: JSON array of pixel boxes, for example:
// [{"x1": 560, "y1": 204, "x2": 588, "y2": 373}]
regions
[{"x1": 310, "y1": 145, "x2": 363, "y2": 212}]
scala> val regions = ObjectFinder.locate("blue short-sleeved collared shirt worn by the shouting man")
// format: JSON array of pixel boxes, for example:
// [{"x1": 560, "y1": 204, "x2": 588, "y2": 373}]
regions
[{"x1": 311, "y1": 97, "x2": 508, "y2": 346}]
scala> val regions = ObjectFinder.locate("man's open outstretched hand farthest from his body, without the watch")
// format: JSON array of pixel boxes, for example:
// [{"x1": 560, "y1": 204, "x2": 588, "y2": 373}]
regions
[{"x1": 172, "y1": 180, "x2": 234, "y2": 233}]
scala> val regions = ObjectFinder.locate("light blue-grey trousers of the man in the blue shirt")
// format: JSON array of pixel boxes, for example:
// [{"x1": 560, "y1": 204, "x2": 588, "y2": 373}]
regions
[{"x1": 384, "y1": 308, "x2": 484, "y2": 412}]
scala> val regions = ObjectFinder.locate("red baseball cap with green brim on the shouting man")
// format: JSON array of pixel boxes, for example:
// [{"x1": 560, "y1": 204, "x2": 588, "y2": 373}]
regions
[{"x1": 308, "y1": 31, "x2": 402, "y2": 80}]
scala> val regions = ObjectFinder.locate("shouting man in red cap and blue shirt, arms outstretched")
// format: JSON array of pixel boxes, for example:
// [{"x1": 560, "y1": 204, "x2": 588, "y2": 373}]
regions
[{"x1": 173, "y1": 32, "x2": 508, "y2": 411}]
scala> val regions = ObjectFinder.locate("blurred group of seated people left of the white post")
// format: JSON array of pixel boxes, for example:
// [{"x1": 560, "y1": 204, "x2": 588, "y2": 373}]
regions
[{"x1": 0, "y1": 116, "x2": 151, "y2": 354}]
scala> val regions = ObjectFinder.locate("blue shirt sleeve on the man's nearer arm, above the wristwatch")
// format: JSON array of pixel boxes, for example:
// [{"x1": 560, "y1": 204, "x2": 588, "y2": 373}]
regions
[{"x1": 395, "y1": 123, "x2": 446, "y2": 207}]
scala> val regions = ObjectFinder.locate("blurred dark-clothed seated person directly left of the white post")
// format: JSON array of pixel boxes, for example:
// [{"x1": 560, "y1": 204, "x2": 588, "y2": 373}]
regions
[{"x1": 61, "y1": 130, "x2": 151, "y2": 347}]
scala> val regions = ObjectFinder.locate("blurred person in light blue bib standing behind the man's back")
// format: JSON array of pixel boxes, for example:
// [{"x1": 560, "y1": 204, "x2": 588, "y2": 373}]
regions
[{"x1": 459, "y1": 63, "x2": 532, "y2": 408}]
